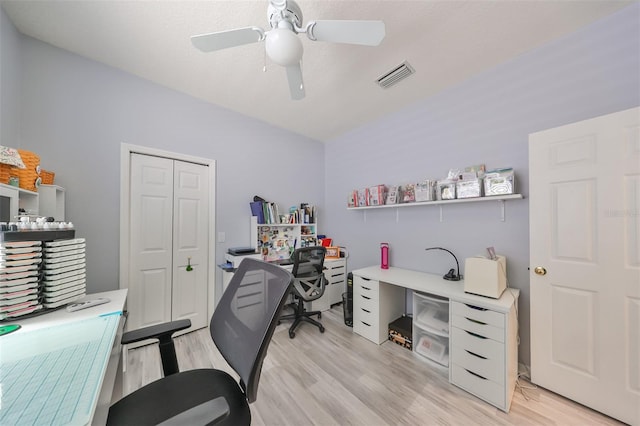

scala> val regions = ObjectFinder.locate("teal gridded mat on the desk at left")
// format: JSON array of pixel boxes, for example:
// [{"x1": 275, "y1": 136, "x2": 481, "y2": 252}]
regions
[{"x1": 0, "y1": 315, "x2": 120, "y2": 426}]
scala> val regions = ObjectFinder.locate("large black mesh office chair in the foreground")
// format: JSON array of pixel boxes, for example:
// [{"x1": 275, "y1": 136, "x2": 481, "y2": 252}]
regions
[{"x1": 107, "y1": 259, "x2": 293, "y2": 425}]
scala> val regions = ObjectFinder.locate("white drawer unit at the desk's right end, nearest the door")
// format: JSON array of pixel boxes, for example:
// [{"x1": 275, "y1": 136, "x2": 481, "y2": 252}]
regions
[{"x1": 449, "y1": 301, "x2": 518, "y2": 411}]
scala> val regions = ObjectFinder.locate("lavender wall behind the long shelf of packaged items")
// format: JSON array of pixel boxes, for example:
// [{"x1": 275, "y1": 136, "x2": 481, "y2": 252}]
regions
[{"x1": 324, "y1": 4, "x2": 640, "y2": 365}]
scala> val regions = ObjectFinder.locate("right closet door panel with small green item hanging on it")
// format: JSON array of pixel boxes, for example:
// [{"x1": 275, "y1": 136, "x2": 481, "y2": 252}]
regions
[{"x1": 172, "y1": 161, "x2": 209, "y2": 329}]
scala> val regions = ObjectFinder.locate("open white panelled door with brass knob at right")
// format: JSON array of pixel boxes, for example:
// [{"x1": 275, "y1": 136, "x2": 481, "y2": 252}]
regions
[{"x1": 529, "y1": 108, "x2": 640, "y2": 424}]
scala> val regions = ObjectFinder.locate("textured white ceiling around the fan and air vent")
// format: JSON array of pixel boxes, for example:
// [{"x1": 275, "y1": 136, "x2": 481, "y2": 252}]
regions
[{"x1": 0, "y1": 0, "x2": 632, "y2": 141}]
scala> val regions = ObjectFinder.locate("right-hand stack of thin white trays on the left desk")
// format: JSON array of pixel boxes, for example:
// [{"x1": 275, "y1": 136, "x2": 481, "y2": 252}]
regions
[{"x1": 42, "y1": 238, "x2": 86, "y2": 308}]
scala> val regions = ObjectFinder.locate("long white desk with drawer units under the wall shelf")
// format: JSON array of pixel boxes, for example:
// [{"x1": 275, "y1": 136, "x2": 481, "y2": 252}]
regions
[{"x1": 353, "y1": 266, "x2": 520, "y2": 412}]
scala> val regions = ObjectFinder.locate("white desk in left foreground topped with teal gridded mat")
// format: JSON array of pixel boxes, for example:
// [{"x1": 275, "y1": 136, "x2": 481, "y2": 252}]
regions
[{"x1": 0, "y1": 290, "x2": 127, "y2": 425}]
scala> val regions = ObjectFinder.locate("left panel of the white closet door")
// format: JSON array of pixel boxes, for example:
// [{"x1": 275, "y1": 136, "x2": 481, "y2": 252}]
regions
[{"x1": 127, "y1": 154, "x2": 174, "y2": 330}]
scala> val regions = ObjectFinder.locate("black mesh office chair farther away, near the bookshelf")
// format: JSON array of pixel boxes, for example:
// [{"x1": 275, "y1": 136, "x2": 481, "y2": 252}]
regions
[{"x1": 280, "y1": 246, "x2": 327, "y2": 339}]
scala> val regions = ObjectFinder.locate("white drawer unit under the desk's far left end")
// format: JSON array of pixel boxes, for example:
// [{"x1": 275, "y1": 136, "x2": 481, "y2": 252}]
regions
[{"x1": 353, "y1": 275, "x2": 404, "y2": 344}]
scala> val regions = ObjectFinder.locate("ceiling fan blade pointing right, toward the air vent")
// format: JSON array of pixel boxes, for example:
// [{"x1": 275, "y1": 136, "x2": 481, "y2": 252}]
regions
[{"x1": 307, "y1": 21, "x2": 385, "y2": 46}]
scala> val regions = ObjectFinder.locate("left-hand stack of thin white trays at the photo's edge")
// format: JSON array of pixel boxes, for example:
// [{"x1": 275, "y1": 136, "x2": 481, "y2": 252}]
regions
[{"x1": 0, "y1": 241, "x2": 42, "y2": 320}]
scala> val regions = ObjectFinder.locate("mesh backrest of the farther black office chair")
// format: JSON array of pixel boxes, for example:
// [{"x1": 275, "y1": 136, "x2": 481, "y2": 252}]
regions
[{"x1": 291, "y1": 246, "x2": 327, "y2": 301}]
